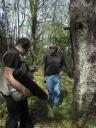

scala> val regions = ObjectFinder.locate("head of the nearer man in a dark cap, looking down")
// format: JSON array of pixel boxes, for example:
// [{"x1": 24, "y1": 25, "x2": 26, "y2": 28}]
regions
[{"x1": 16, "y1": 38, "x2": 31, "y2": 54}]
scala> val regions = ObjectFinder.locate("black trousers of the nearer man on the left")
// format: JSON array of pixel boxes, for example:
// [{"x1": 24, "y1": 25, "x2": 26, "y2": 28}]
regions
[{"x1": 4, "y1": 96, "x2": 34, "y2": 128}]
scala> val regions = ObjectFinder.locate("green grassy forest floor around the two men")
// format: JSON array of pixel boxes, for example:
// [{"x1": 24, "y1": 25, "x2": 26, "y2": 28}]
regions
[{"x1": 0, "y1": 70, "x2": 96, "y2": 128}]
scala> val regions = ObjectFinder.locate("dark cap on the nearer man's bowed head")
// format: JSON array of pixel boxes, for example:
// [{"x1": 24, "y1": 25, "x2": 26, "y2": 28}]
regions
[{"x1": 16, "y1": 38, "x2": 31, "y2": 50}]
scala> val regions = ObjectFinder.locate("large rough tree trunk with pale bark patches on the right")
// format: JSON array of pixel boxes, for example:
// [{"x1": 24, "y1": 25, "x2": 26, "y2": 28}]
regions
[{"x1": 70, "y1": 0, "x2": 96, "y2": 127}]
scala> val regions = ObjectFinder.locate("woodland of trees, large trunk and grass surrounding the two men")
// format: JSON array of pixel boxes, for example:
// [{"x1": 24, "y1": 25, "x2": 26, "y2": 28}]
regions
[{"x1": 0, "y1": 0, "x2": 96, "y2": 128}]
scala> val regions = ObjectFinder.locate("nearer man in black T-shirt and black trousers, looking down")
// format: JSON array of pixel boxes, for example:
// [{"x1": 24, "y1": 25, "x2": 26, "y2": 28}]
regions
[{"x1": 2, "y1": 38, "x2": 34, "y2": 128}]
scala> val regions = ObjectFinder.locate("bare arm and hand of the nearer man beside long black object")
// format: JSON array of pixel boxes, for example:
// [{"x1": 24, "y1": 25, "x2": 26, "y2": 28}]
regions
[{"x1": 4, "y1": 67, "x2": 31, "y2": 97}]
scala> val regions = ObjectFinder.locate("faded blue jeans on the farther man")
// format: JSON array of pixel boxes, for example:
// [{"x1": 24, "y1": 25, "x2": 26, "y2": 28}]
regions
[{"x1": 46, "y1": 74, "x2": 61, "y2": 106}]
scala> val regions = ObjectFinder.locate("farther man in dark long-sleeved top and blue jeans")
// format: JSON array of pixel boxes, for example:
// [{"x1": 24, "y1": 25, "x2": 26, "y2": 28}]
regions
[{"x1": 44, "y1": 44, "x2": 65, "y2": 107}]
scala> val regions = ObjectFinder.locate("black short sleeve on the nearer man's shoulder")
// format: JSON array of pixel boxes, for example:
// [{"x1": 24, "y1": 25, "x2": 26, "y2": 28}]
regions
[{"x1": 3, "y1": 50, "x2": 19, "y2": 68}]
